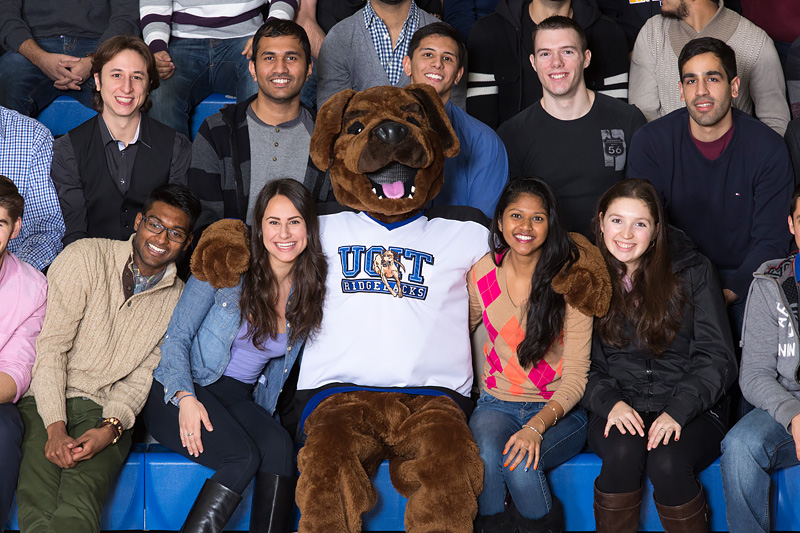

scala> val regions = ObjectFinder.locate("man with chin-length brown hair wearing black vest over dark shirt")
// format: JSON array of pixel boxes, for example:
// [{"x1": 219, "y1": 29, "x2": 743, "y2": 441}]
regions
[{"x1": 50, "y1": 35, "x2": 191, "y2": 246}]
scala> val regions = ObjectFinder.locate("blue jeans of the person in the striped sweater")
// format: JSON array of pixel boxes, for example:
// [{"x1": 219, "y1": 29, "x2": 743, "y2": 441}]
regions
[{"x1": 149, "y1": 37, "x2": 258, "y2": 137}]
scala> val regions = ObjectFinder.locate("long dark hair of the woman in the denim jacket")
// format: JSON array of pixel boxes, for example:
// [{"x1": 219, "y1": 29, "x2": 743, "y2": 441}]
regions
[{"x1": 239, "y1": 178, "x2": 328, "y2": 348}]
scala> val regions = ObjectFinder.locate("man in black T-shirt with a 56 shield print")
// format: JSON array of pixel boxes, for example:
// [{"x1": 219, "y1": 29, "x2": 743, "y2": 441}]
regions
[{"x1": 497, "y1": 16, "x2": 646, "y2": 237}]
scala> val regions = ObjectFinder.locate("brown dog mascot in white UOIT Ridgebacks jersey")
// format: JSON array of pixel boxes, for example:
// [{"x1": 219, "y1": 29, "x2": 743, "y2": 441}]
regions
[{"x1": 297, "y1": 84, "x2": 488, "y2": 533}]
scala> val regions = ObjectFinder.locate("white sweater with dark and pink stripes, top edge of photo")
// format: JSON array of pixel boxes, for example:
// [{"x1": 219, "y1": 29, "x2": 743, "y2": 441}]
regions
[{"x1": 139, "y1": 0, "x2": 298, "y2": 53}]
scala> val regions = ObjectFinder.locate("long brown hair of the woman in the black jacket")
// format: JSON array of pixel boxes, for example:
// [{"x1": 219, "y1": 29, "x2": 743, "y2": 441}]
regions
[{"x1": 593, "y1": 178, "x2": 686, "y2": 355}]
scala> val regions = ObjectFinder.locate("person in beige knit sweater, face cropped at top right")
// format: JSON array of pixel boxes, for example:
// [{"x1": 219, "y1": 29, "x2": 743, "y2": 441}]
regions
[{"x1": 629, "y1": 0, "x2": 790, "y2": 135}]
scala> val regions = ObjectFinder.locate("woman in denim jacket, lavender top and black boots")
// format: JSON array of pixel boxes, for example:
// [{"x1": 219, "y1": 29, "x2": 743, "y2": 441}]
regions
[{"x1": 144, "y1": 179, "x2": 327, "y2": 532}]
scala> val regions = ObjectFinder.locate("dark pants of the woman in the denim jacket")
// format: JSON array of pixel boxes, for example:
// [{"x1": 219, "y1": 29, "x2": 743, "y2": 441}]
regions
[{"x1": 143, "y1": 376, "x2": 295, "y2": 494}]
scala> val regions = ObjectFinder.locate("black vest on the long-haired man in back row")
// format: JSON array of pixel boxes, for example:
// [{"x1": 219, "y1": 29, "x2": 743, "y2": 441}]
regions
[{"x1": 68, "y1": 114, "x2": 175, "y2": 240}]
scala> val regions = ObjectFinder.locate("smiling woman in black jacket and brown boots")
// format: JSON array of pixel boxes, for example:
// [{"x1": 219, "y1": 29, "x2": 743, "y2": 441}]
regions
[{"x1": 583, "y1": 179, "x2": 737, "y2": 533}]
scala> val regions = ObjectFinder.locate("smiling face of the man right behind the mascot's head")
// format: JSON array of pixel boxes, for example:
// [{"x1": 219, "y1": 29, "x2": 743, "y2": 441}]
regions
[{"x1": 403, "y1": 35, "x2": 464, "y2": 102}]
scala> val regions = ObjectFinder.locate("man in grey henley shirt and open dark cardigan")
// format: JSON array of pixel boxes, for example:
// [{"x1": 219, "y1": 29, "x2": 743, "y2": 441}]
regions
[{"x1": 188, "y1": 19, "x2": 330, "y2": 228}]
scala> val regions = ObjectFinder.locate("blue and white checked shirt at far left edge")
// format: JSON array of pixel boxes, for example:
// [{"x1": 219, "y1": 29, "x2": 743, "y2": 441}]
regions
[{"x1": 0, "y1": 106, "x2": 64, "y2": 270}]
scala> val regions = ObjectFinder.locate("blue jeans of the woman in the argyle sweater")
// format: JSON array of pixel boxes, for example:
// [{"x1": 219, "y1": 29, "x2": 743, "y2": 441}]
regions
[{"x1": 469, "y1": 392, "x2": 587, "y2": 519}]
